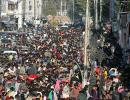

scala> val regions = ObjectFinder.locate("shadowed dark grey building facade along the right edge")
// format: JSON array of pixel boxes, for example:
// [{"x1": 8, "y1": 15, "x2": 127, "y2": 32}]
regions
[{"x1": 118, "y1": 0, "x2": 130, "y2": 64}]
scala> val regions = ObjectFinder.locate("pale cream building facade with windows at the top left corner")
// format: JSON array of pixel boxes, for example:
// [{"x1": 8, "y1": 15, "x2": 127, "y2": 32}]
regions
[{"x1": 0, "y1": 0, "x2": 42, "y2": 29}]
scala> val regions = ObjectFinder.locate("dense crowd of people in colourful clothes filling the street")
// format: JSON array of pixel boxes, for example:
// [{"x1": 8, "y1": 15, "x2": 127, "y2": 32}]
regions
[{"x1": 0, "y1": 27, "x2": 129, "y2": 100}]
